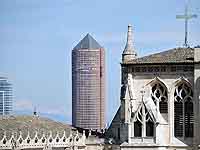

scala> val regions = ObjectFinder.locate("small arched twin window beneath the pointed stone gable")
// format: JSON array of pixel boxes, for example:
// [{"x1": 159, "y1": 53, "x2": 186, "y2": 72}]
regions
[{"x1": 134, "y1": 104, "x2": 154, "y2": 137}]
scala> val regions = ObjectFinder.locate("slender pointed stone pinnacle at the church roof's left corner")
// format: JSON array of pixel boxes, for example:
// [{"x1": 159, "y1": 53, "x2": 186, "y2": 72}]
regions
[{"x1": 122, "y1": 24, "x2": 137, "y2": 62}]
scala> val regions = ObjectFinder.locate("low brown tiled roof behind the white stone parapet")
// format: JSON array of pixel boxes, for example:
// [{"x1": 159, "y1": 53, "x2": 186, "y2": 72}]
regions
[{"x1": 0, "y1": 115, "x2": 75, "y2": 140}]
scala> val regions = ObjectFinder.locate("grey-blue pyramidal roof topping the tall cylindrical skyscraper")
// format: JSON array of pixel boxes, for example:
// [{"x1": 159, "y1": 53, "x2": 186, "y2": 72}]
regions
[{"x1": 73, "y1": 33, "x2": 102, "y2": 50}]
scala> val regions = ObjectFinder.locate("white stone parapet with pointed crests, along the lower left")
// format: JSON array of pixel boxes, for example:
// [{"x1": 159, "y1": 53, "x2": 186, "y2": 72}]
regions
[{"x1": 0, "y1": 131, "x2": 86, "y2": 150}]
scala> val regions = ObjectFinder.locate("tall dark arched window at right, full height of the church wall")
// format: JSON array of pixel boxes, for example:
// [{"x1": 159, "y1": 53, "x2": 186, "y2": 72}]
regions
[{"x1": 174, "y1": 82, "x2": 194, "y2": 137}]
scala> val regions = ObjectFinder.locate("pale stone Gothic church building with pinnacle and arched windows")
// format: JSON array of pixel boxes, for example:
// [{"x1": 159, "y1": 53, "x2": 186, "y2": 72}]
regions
[{"x1": 108, "y1": 25, "x2": 200, "y2": 150}]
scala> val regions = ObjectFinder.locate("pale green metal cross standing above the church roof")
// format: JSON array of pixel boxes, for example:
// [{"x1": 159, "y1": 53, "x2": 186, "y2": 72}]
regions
[{"x1": 176, "y1": 0, "x2": 197, "y2": 47}]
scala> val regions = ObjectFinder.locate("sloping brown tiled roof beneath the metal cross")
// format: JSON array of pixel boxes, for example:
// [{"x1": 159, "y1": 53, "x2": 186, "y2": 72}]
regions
[{"x1": 123, "y1": 48, "x2": 194, "y2": 64}]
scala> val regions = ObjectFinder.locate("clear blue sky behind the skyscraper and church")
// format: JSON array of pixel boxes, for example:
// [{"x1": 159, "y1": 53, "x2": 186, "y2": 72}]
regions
[{"x1": 0, "y1": 0, "x2": 200, "y2": 123}]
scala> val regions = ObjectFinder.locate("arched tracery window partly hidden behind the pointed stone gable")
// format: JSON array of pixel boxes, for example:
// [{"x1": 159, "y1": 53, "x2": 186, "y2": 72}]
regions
[{"x1": 151, "y1": 82, "x2": 168, "y2": 113}]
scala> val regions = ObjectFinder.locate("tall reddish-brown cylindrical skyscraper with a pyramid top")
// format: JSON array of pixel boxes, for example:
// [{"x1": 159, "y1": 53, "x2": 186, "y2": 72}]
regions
[{"x1": 72, "y1": 34, "x2": 105, "y2": 129}]
